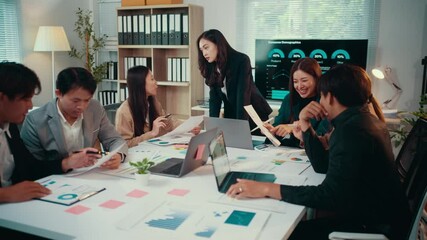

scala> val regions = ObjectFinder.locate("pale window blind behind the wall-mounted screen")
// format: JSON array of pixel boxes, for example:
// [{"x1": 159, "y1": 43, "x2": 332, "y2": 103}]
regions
[{"x1": 236, "y1": 0, "x2": 380, "y2": 70}]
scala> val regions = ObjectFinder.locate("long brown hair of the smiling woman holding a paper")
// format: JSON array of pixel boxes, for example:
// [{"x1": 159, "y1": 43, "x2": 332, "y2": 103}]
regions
[{"x1": 289, "y1": 58, "x2": 322, "y2": 122}]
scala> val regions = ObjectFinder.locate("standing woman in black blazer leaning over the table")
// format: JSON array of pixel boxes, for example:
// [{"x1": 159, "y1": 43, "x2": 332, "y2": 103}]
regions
[{"x1": 197, "y1": 29, "x2": 272, "y2": 133}]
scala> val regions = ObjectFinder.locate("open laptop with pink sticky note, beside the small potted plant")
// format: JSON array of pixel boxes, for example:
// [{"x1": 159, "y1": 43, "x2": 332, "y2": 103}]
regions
[{"x1": 148, "y1": 129, "x2": 217, "y2": 177}]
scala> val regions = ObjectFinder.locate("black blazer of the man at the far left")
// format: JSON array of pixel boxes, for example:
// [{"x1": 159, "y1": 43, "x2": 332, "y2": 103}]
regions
[{"x1": 6, "y1": 123, "x2": 63, "y2": 184}]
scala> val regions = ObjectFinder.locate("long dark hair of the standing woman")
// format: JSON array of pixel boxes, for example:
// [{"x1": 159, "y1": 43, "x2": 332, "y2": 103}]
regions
[{"x1": 197, "y1": 29, "x2": 235, "y2": 87}]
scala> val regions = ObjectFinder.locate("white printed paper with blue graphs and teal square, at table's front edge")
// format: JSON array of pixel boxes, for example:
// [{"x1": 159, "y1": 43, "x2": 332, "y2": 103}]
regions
[{"x1": 135, "y1": 202, "x2": 270, "y2": 239}]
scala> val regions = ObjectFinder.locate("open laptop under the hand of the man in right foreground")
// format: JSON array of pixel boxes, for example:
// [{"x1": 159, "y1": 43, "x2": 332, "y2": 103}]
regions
[{"x1": 209, "y1": 131, "x2": 276, "y2": 193}]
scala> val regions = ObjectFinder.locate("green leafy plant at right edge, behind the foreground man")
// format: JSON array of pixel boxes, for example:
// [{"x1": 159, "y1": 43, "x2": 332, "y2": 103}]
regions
[{"x1": 390, "y1": 94, "x2": 427, "y2": 147}]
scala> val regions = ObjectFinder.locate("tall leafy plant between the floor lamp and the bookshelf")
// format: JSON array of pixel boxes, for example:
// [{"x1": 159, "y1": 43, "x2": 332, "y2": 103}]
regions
[{"x1": 68, "y1": 8, "x2": 107, "y2": 82}]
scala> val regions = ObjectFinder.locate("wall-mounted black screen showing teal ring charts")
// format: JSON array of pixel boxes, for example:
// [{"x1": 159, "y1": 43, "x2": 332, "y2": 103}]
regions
[{"x1": 255, "y1": 39, "x2": 368, "y2": 100}]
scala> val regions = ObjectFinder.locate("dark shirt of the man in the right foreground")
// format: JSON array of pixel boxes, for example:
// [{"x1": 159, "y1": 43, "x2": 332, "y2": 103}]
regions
[{"x1": 281, "y1": 105, "x2": 410, "y2": 239}]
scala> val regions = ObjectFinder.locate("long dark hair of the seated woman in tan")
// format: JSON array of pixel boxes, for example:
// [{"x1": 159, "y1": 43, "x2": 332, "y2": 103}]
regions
[{"x1": 126, "y1": 66, "x2": 158, "y2": 136}]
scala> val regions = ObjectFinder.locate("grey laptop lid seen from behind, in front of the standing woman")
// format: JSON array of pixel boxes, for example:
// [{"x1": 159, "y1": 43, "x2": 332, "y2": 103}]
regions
[{"x1": 204, "y1": 117, "x2": 254, "y2": 150}]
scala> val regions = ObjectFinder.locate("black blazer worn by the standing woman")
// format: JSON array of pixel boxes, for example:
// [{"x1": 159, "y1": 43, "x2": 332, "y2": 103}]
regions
[{"x1": 209, "y1": 50, "x2": 273, "y2": 120}]
